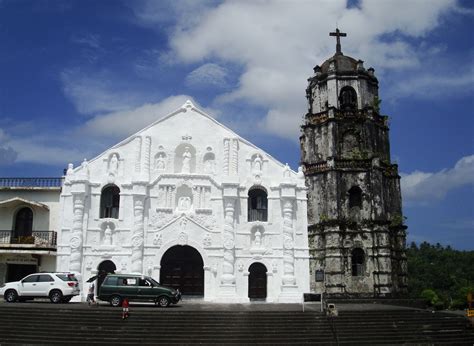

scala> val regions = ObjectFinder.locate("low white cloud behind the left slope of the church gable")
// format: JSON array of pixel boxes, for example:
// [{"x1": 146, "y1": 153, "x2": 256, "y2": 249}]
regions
[{"x1": 0, "y1": 95, "x2": 218, "y2": 166}]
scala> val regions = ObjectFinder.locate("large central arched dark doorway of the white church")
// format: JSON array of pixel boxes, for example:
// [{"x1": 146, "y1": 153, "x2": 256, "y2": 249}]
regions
[{"x1": 160, "y1": 245, "x2": 204, "y2": 296}]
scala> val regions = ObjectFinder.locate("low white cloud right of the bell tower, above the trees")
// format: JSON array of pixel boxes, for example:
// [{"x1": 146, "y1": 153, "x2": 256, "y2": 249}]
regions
[{"x1": 401, "y1": 155, "x2": 474, "y2": 204}]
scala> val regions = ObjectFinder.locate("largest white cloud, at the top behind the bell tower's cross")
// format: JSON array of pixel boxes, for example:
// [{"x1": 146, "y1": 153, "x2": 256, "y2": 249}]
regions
[{"x1": 130, "y1": 0, "x2": 456, "y2": 140}]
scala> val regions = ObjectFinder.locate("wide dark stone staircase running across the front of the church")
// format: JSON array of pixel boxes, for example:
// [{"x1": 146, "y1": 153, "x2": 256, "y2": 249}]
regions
[{"x1": 0, "y1": 303, "x2": 474, "y2": 345}]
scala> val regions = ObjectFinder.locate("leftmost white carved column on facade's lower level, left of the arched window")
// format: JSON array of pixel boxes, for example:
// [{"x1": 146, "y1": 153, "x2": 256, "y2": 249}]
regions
[{"x1": 69, "y1": 192, "x2": 84, "y2": 273}]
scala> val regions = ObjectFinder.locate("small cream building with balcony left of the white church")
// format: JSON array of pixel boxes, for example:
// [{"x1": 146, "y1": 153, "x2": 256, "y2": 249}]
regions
[{"x1": 0, "y1": 178, "x2": 62, "y2": 284}]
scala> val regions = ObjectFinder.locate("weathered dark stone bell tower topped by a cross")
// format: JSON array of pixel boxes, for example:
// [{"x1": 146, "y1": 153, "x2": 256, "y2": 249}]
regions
[{"x1": 300, "y1": 29, "x2": 407, "y2": 298}]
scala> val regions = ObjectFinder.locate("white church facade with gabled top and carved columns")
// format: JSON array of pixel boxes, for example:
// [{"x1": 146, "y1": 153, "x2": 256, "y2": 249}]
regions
[{"x1": 57, "y1": 101, "x2": 309, "y2": 302}]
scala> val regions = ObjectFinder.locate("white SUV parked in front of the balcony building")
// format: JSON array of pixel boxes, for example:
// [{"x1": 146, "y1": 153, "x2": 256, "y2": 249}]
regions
[{"x1": 0, "y1": 273, "x2": 80, "y2": 304}]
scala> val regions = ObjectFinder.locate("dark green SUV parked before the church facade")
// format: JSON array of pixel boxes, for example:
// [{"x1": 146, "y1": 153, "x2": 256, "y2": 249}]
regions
[{"x1": 98, "y1": 274, "x2": 181, "y2": 307}]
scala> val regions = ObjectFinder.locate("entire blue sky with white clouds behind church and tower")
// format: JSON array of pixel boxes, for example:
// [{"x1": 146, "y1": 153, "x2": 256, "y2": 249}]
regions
[{"x1": 0, "y1": 0, "x2": 474, "y2": 250}]
